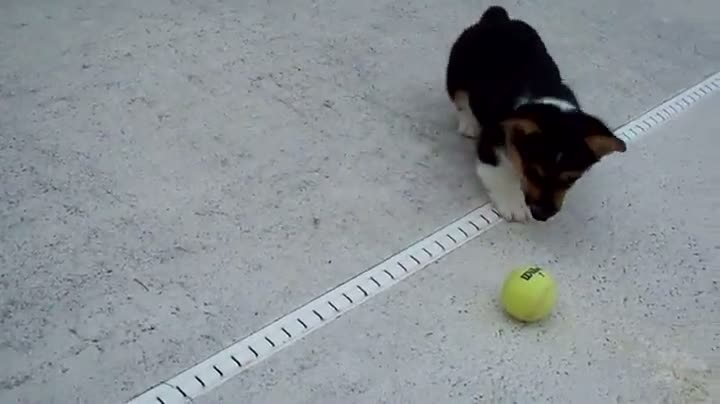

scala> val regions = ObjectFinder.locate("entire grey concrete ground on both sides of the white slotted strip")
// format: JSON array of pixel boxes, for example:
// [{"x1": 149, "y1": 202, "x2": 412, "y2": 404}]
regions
[{"x1": 0, "y1": 0, "x2": 720, "y2": 403}]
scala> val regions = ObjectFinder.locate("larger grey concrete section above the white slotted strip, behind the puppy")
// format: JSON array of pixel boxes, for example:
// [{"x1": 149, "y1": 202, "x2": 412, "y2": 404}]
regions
[{"x1": 0, "y1": 0, "x2": 720, "y2": 403}]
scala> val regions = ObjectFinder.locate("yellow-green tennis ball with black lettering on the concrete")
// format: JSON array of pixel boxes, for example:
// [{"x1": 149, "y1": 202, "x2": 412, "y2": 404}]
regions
[{"x1": 501, "y1": 267, "x2": 557, "y2": 322}]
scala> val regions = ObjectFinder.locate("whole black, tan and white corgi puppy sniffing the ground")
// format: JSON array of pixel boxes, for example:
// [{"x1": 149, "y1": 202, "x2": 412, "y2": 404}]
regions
[{"x1": 446, "y1": 6, "x2": 626, "y2": 221}]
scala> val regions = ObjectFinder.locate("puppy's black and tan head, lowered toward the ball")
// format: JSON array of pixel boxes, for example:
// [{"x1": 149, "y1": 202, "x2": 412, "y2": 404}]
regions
[{"x1": 502, "y1": 105, "x2": 626, "y2": 221}]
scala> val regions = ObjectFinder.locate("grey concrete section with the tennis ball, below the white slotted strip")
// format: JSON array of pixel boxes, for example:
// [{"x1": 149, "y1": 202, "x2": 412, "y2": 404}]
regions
[{"x1": 201, "y1": 95, "x2": 720, "y2": 404}]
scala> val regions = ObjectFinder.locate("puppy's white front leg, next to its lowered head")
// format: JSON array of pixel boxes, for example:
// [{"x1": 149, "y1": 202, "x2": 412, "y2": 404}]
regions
[{"x1": 476, "y1": 159, "x2": 532, "y2": 222}]
